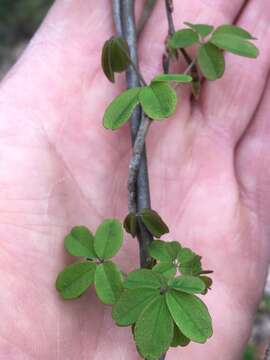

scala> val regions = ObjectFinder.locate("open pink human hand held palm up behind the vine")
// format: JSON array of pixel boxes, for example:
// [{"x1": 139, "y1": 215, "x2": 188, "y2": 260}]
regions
[{"x1": 0, "y1": 0, "x2": 270, "y2": 360}]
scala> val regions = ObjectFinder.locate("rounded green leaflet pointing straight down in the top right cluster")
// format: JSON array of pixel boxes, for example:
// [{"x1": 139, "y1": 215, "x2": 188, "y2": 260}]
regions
[{"x1": 198, "y1": 43, "x2": 225, "y2": 80}]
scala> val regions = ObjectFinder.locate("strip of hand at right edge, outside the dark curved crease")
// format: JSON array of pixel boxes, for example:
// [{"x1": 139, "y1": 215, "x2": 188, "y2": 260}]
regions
[{"x1": 236, "y1": 73, "x2": 270, "y2": 260}]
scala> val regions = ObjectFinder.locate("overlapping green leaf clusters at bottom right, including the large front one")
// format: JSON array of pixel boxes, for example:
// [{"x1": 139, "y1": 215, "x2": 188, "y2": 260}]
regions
[{"x1": 112, "y1": 240, "x2": 213, "y2": 360}]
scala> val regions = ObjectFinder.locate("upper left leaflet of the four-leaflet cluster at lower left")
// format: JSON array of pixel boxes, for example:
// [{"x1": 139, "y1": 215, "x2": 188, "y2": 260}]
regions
[{"x1": 65, "y1": 226, "x2": 97, "y2": 259}]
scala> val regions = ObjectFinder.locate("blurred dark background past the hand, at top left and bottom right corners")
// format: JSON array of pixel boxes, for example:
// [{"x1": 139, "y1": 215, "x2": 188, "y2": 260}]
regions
[{"x1": 0, "y1": 0, "x2": 270, "y2": 360}]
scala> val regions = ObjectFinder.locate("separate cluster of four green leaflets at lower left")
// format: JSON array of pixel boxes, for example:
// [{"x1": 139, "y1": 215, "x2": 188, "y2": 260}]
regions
[{"x1": 56, "y1": 219, "x2": 123, "y2": 304}]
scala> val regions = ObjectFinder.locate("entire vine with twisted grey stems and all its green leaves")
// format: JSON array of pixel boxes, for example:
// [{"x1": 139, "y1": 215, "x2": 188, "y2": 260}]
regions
[{"x1": 53, "y1": 0, "x2": 259, "y2": 360}]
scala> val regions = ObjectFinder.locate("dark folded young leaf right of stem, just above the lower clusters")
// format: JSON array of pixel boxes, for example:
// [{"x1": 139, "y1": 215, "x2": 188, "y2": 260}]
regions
[{"x1": 140, "y1": 209, "x2": 169, "y2": 238}]
